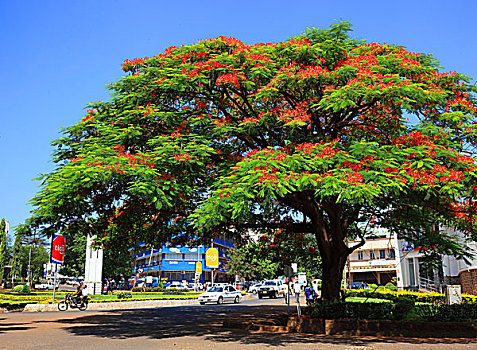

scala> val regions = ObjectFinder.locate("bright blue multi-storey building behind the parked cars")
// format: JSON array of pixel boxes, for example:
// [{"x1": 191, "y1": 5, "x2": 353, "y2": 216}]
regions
[{"x1": 133, "y1": 239, "x2": 234, "y2": 283}]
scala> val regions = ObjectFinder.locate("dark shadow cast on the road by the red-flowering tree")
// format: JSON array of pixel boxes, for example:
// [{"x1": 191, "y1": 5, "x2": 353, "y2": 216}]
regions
[{"x1": 39, "y1": 305, "x2": 475, "y2": 346}]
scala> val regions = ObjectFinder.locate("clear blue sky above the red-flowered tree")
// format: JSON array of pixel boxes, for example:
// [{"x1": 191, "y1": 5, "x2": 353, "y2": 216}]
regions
[{"x1": 0, "y1": 0, "x2": 477, "y2": 238}]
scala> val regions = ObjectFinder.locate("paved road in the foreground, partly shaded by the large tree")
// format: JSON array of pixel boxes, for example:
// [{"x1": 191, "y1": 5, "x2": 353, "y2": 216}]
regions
[{"x1": 0, "y1": 299, "x2": 477, "y2": 350}]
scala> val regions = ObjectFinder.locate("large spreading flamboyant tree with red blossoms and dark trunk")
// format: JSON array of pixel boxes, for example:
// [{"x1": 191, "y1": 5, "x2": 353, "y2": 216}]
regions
[{"x1": 28, "y1": 23, "x2": 477, "y2": 300}]
